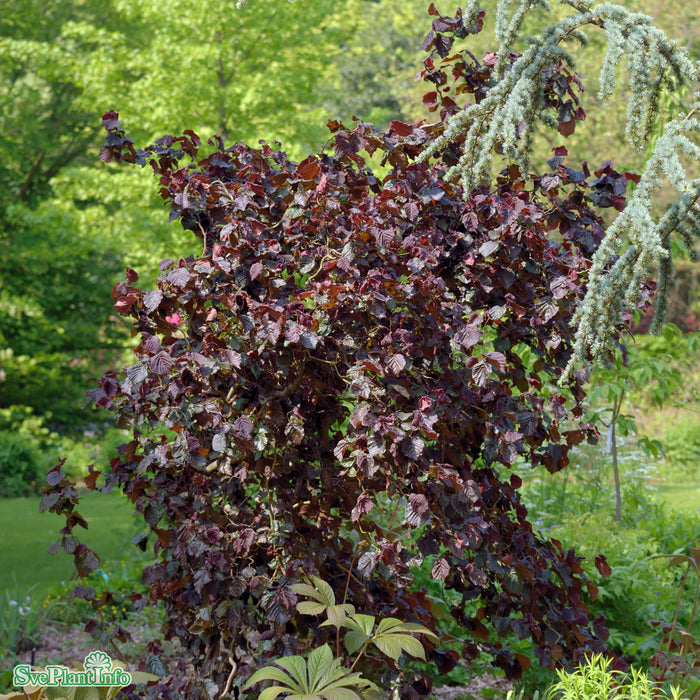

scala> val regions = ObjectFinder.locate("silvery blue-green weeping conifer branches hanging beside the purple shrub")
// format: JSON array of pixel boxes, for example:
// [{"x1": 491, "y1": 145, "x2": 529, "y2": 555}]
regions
[{"x1": 421, "y1": 0, "x2": 700, "y2": 381}]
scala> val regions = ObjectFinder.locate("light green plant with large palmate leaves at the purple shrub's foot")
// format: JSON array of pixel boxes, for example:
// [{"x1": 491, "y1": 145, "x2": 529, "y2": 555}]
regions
[{"x1": 245, "y1": 576, "x2": 438, "y2": 700}]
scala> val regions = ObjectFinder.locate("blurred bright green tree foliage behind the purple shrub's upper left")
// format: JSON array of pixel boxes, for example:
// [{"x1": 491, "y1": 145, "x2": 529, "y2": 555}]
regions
[{"x1": 0, "y1": 0, "x2": 424, "y2": 438}]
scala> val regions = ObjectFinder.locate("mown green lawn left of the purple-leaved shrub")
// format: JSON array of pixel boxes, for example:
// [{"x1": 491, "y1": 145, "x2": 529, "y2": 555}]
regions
[{"x1": 0, "y1": 492, "x2": 144, "y2": 595}]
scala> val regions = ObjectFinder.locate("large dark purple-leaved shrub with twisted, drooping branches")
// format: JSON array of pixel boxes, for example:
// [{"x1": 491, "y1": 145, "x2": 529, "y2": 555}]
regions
[{"x1": 44, "y1": 1, "x2": 668, "y2": 698}]
